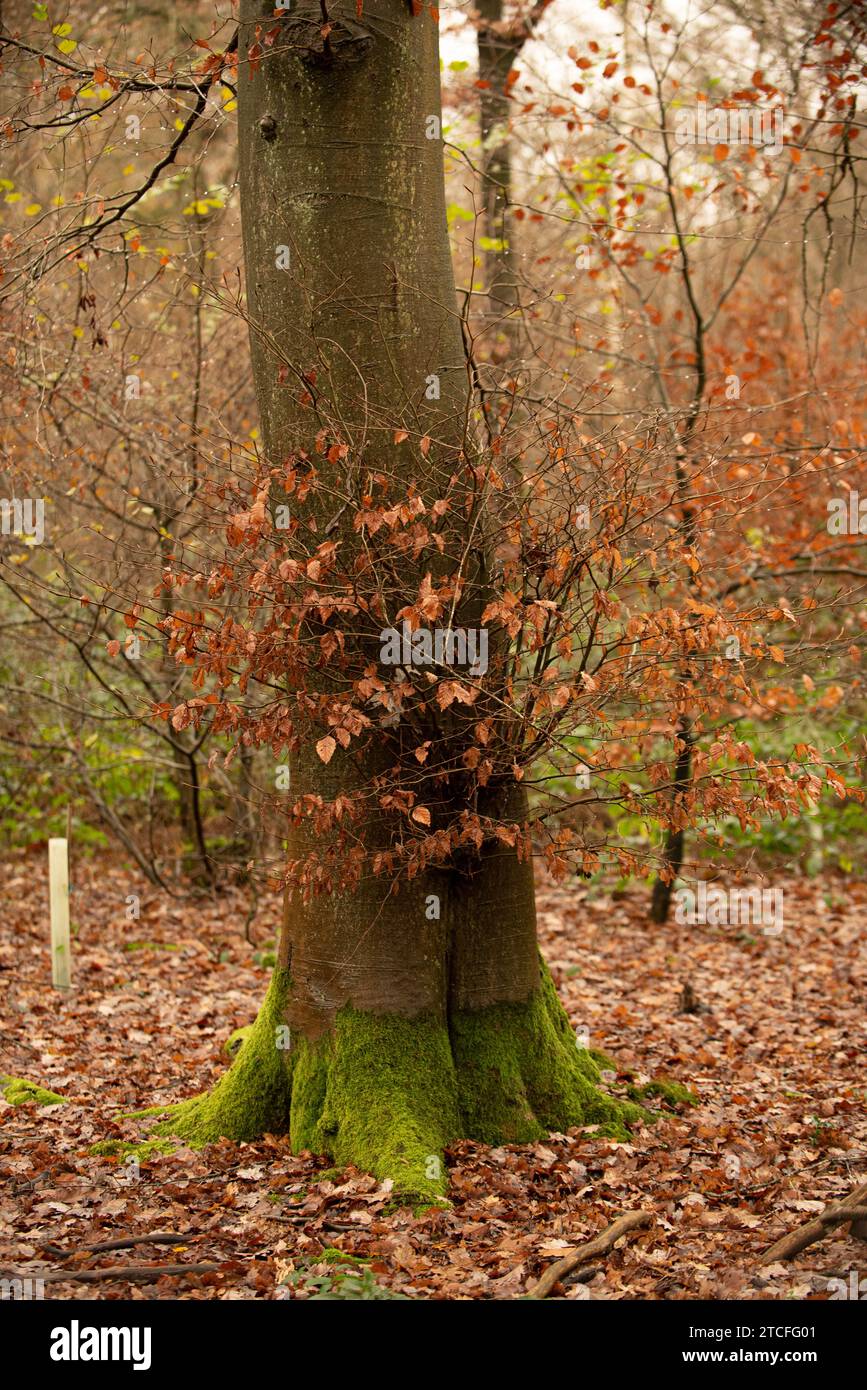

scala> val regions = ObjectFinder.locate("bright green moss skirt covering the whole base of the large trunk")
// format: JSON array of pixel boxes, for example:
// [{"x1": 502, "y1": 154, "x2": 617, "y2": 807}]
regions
[{"x1": 99, "y1": 962, "x2": 650, "y2": 1202}]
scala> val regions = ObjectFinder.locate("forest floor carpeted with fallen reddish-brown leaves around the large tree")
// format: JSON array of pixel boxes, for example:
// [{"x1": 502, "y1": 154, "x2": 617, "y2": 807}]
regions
[{"x1": 0, "y1": 853, "x2": 867, "y2": 1300}]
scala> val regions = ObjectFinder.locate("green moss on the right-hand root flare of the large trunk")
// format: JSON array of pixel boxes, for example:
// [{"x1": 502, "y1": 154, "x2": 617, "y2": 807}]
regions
[{"x1": 450, "y1": 962, "x2": 649, "y2": 1144}]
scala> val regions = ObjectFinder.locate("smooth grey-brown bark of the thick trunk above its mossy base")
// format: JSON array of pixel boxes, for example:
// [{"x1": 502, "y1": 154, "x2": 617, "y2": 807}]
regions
[{"x1": 233, "y1": 0, "x2": 539, "y2": 1037}]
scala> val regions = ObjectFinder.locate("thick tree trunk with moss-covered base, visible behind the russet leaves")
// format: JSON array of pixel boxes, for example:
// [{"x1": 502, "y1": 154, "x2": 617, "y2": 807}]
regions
[{"x1": 154, "y1": 0, "x2": 642, "y2": 1198}]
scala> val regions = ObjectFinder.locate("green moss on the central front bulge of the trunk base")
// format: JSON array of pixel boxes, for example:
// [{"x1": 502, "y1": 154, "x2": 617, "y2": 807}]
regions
[{"x1": 291, "y1": 1005, "x2": 460, "y2": 1201}]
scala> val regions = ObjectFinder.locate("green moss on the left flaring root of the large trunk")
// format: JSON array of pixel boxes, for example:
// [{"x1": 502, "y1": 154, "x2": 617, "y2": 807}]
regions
[{"x1": 153, "y1": 970, "x2": 292, "y2": 1147}]
